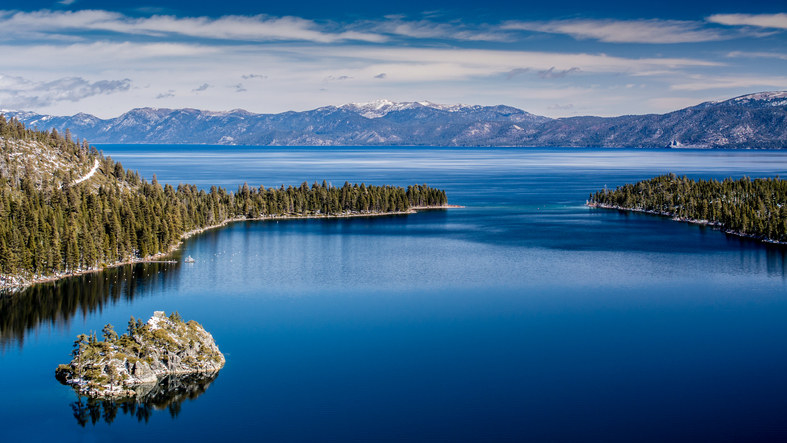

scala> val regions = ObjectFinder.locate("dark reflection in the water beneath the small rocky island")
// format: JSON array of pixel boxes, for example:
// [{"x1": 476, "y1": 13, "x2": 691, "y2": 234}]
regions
[{"x1": 71, "y1": 372, "x2": 219, "y2": 427}]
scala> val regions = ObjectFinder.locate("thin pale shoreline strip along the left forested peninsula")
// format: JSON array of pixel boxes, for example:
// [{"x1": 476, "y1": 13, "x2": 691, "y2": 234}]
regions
[{"x1": 0, "y1": 205, "x2": 464, "y2": 297}]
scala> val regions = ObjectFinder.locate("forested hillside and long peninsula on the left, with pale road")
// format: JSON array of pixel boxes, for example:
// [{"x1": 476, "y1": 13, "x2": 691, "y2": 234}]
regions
[{"x1": 0, "y1": 115, "x2": 446, "y2": 289}]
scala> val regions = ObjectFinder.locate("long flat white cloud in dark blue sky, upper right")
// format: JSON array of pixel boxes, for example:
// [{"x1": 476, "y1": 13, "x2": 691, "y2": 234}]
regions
[{"x1": 502, "y1": 19, "x2": 728, "y2": 43}]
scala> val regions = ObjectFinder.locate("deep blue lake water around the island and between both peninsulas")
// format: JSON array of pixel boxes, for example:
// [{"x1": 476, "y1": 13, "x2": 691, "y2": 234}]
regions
[{"x1": 0, "y1": 145, "x2": 787, "y2": 442}]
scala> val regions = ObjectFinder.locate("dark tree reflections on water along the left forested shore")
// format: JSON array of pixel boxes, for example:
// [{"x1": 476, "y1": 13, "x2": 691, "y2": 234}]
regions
[{"x1": 0, "y1": 263, "x2": 179, "y2": 351}]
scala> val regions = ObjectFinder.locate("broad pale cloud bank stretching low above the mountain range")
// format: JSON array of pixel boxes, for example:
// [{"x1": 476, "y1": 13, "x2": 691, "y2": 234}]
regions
[{"x1": 0, "y1": 42, "x2": 719, "y2": 117}]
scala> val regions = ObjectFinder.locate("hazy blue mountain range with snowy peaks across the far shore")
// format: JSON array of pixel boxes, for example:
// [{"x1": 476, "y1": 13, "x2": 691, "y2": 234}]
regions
[{"x1": 0, "y1": 91, "x2": 787, "y2": 149}]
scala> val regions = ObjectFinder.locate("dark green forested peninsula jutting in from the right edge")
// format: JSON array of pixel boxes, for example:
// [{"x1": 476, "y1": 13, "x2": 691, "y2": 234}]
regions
[{"x1": 588, "y1": 174, "x2": 787, "y2": 243}]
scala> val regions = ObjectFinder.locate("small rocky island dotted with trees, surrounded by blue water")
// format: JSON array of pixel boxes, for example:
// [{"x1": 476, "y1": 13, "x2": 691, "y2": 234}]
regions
[{"x1": 55, "y1": 311, "x2": 225, "y2": 399}]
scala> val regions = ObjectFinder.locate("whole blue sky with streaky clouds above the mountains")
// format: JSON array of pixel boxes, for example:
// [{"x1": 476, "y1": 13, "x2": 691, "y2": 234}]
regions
[{"x1": 0, "y1": 0, "x2": 787, "y2": 118}]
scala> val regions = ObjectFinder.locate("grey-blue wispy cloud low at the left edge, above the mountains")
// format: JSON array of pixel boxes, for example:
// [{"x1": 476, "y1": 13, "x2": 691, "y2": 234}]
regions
[{"x1": 0, "y1": 75, "x2": 131, "y2": 109}]
